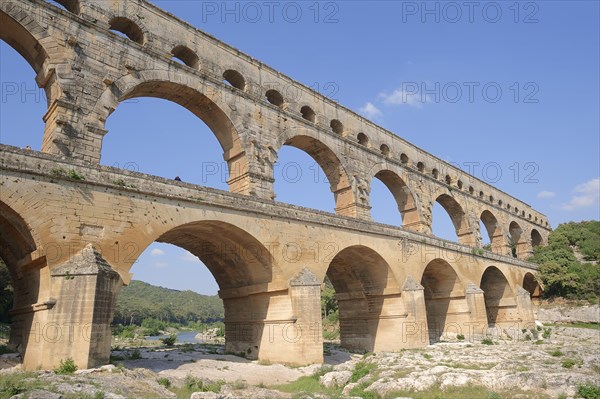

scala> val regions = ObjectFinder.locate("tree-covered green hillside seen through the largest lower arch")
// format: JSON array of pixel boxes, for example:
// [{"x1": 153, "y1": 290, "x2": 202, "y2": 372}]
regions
[{"x1": 114, "y1": 280, "x2": 224, "y2": 324}]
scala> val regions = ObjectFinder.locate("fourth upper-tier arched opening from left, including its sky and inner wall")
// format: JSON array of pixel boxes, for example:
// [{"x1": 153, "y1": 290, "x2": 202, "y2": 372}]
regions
[{"x1": 370, "y1": 170, "x2": 420, "y2": 230}]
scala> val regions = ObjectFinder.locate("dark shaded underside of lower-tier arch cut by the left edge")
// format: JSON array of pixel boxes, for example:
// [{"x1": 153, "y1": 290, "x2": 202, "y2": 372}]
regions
[{"x1": 0, "y1": 201, "x2": 45, "y2": 361}]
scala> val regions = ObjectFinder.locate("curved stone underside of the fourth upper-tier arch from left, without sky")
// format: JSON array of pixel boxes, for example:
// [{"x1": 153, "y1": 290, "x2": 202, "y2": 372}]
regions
[{"x1": 373, "y1": 169, "x2": 422, "y2": 231}]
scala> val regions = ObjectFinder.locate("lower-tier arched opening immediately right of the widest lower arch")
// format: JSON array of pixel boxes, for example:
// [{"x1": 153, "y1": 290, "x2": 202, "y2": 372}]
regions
[{"x1": 327, "y1": 246, "x2": 402, "y2": 351}]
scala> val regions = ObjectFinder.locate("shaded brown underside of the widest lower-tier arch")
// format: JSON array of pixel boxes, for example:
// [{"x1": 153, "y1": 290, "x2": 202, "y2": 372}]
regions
[{"x1": 137, "y1": 220, "x2": 287, "y2": 359}]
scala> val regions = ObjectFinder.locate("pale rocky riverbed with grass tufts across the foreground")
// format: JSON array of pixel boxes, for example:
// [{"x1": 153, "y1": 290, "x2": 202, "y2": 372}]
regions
[{"x1": 0, "y1": 326, "x2": 600, "y2": 399}]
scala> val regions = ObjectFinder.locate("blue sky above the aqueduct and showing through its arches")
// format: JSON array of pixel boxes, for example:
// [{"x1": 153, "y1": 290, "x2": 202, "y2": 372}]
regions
[{"x1": 0, "y1": 0, "x2": 600, "y2": 294}]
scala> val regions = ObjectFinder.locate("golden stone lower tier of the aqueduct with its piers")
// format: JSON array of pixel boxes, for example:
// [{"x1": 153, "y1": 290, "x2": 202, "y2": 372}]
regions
[{"x1": 0, "y1": 146, "x2": 539, "y2": 369}]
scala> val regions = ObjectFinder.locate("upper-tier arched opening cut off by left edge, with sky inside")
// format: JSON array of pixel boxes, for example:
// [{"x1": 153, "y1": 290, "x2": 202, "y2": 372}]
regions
[{"x1": 0, "y1": 11, "x2": 54, "y2": 151}]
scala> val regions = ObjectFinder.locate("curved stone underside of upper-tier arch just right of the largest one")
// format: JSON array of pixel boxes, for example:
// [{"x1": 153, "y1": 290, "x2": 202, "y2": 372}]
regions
[{"x1": 277, "y1": 130, "x2": 357, "y2": 216}]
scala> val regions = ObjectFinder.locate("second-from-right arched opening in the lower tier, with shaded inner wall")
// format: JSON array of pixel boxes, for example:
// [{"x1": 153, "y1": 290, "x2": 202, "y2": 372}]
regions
[{"x1": 480, "y1": 266, "x2": 517, "y2": 327}]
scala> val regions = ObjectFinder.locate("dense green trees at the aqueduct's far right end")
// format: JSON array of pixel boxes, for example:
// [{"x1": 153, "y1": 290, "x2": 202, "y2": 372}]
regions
[{"x1": 528, "y1": 221, "x2": 600, "y2": 302}]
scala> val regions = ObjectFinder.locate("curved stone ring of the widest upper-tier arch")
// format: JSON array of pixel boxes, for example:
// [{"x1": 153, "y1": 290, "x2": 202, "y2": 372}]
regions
[{"x1": 88, "y1": 71, "x2": 250, "y2": 194}]
